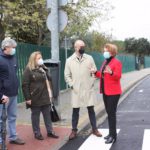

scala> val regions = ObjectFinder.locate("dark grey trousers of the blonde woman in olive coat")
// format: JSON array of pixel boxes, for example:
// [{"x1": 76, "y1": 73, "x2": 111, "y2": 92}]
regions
[{"x1": 31, "y1": 105, "x2": 53, "y2": 134}]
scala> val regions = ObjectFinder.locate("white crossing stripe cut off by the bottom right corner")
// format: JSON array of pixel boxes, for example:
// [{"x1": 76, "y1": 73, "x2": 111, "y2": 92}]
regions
[{"x1": 142, "y1": 129, "x2": 150, "y2": 150}]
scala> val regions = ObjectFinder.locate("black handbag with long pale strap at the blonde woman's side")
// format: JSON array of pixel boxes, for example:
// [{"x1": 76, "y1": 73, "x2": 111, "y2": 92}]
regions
[{"x1": 42, "y1": 69, "x2": 60, "y2": 122}]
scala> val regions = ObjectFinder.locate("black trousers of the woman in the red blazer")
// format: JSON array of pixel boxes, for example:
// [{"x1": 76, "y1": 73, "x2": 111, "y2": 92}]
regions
[{"x1": 103, "y1": 94, "x2": 120, "y2": 137}]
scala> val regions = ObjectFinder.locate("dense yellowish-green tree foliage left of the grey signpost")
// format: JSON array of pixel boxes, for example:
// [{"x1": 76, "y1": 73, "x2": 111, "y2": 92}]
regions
[{"x1": 2, "y1": 0, "x2": 48, "y2": 45}]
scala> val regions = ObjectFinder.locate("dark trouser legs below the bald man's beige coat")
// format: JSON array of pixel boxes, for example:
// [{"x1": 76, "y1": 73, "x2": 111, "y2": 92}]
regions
[{"x1": 72, "y1": 106, "x2": 97, "y2": 131}]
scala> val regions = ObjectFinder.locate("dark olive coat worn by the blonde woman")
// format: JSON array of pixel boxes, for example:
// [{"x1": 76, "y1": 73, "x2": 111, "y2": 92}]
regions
[{"x1": 22, "y1": 67, "x2": 52, "y2": 107}]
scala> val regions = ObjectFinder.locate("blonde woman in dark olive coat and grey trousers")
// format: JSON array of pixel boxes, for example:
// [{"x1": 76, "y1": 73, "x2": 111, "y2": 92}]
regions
[{"x1": 22, "y1": 51, "x2": 58, "y2": 140}]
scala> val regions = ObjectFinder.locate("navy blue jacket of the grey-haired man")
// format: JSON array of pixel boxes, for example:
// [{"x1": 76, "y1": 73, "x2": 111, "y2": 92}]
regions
[{"x1": 0, "y1": 49, "x2": 19, "y2": 98}]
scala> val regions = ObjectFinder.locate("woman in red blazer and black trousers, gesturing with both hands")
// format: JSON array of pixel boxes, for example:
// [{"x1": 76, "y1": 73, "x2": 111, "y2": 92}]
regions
[{"x1": 91, "y1": 44, "x2": 122, "y2": 144}]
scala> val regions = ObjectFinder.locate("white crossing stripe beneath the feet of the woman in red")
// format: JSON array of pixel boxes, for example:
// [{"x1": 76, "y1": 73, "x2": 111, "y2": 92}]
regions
[{"x1": 78, "y1": 129, "x2": 120, "y2": 150}]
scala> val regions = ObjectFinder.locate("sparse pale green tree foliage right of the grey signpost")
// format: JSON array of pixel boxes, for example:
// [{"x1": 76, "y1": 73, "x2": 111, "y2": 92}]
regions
[{"x1": 61, "y1": 0, "x2": 112, "y2": 38}]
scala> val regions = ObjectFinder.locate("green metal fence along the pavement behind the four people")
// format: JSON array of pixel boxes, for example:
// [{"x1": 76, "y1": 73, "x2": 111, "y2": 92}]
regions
[{"x1": 16, "y1": 43, "x2": 135, "y2": 103}]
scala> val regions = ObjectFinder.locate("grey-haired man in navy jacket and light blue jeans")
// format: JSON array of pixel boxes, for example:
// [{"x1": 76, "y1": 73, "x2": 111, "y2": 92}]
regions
[{"x1": 0, "y1": 39, "x2": 25, "y2": 145}]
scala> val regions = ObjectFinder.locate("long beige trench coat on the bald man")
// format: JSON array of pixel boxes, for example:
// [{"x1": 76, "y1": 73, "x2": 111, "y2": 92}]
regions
[{"x1": 64, "y1": 53, "x2": 97, "y2": 108}]
